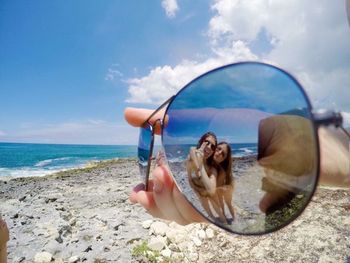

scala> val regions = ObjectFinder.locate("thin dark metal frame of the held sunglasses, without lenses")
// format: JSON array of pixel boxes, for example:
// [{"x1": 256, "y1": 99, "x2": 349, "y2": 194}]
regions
[{"x1": 142, "y1": 62, "x2": 350, "y2": 235}]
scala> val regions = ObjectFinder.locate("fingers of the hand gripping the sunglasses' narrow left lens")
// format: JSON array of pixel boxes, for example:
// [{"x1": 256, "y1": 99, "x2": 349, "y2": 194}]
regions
[{"x1": 124, "y1": 108, "x2": 206, "y2": 225}]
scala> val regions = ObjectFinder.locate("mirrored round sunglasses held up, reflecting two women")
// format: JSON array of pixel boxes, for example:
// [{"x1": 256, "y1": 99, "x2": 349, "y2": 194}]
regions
[{"x1": 138, "y1": 62, "x2": 349, "y2": 235}]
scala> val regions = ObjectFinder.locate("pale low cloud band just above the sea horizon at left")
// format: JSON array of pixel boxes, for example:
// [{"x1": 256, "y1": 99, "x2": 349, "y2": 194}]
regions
[{"x1": 1, "y1": 119, "x2": 138, "y2": 144}]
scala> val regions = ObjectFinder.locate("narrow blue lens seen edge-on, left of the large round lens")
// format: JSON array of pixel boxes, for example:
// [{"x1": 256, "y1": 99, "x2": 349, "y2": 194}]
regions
[{"x1": 137, "y1": 124, "x2": 152, "y2": 180}]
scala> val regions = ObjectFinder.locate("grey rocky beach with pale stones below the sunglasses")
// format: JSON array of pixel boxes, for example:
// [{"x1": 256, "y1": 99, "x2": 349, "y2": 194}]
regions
[{"x1": 0, "y1": 159, "x2": 350, "y2": 263}]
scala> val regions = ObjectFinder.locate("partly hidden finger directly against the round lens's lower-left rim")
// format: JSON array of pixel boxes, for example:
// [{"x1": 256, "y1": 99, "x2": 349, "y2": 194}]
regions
[{"x1": 173, "y1": 185, "x2": 208, "y2": 223}]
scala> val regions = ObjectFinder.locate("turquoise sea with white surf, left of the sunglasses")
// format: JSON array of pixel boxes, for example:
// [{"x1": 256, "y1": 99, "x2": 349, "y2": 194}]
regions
[{"x1": 0, "y1": 143, "x2": 137, "y2": 177}]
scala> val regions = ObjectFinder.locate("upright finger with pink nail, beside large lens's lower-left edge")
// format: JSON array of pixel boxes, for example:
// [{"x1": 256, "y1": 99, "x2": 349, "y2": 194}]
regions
[{"x1": 153, "y1": 166, "x2": 188, "y2": 225}]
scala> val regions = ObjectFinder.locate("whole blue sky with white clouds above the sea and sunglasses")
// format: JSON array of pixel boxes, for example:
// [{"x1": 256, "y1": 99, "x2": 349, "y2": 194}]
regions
[{"x1": 0, "y1": 0, "x2": 350, "y2": 144}]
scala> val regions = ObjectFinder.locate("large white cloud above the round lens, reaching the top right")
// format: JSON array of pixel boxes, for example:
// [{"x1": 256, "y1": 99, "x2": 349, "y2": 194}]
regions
[{"x1": 128, "y1": 0, "x2": 350, "y2": 112}]
